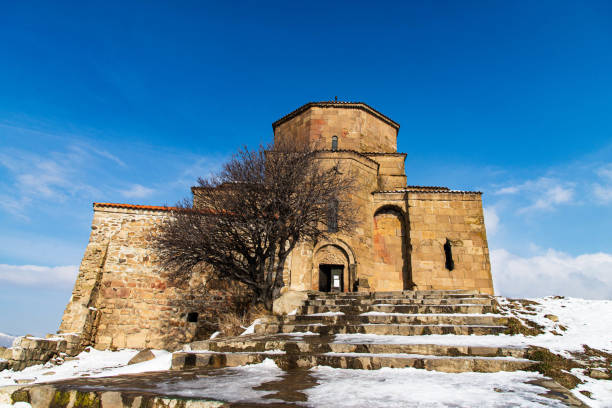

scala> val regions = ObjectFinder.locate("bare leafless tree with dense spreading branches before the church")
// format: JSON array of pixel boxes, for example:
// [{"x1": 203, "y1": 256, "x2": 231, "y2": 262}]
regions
[{"x1": 153, "y1": 140, "x2": 355, "y2": 310}]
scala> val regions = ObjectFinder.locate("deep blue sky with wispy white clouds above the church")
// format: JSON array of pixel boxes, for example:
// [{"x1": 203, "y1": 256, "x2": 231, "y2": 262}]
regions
[{"x1": 0, "y1": 1, "x2": 612, "y2": 334}]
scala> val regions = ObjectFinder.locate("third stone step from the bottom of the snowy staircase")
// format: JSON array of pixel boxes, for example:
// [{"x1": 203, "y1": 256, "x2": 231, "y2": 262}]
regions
[{"x1": 255, "y1": 323, "x2": 507, "y2": 336}]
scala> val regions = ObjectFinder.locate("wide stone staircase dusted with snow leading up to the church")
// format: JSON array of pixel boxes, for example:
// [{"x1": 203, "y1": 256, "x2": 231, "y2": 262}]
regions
[{"x1": 172, "y1": 291, "x2": 535, "y2": 372}]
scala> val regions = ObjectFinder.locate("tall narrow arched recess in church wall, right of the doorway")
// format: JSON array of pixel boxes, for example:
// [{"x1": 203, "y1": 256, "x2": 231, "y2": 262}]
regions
[{"x1": 372, "y1": 206, "x2": 410, "y2": 291}]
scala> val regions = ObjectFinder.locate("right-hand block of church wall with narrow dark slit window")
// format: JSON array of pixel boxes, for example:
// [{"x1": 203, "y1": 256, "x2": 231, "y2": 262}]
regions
[{"x1": 407, "y1": 192, "x2": 493, "y2": 294}]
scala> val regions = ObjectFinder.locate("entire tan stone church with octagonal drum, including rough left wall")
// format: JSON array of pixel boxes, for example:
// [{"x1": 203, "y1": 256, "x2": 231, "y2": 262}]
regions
[{"x1": 59, "y1": 102, "x2": 493, "y2": 348}]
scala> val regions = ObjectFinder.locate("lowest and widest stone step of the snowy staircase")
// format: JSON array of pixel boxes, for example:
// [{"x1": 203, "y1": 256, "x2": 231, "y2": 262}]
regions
[{"x1": 171, "y1": 352, "x2": 535, "y2": 373}]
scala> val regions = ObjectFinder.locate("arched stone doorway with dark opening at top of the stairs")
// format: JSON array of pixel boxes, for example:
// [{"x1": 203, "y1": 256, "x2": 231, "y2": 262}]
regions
[{"x1": 311, "y1": 244, "x2": 352, "y2": 292}]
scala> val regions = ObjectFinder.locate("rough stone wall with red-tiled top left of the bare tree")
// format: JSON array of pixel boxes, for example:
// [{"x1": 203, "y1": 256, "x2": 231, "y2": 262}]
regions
[{"x1": 59, "y1": 204, "x2": 234, "y2": 349}]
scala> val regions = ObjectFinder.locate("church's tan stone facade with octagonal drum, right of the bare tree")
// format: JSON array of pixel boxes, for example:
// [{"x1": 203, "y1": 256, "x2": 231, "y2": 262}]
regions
[{"x1": 272, "y1": 102, "x2": 493, "y2": 294}]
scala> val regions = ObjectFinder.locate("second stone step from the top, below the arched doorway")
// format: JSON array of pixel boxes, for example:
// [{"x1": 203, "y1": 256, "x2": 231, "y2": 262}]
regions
[{"x1": 304, "y1": 298, "x2": 493, "y2": 306}]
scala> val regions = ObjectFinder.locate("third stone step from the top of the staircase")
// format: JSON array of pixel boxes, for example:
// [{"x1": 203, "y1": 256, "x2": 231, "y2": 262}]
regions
[{"x1": 296, "y1": 304, "x2": 493, "y2": 315}]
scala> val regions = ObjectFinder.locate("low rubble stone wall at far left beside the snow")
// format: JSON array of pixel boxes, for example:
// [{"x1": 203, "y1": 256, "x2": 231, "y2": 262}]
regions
[{"x1": 0, "y1": 334, "x2": 81, "y2": 371}]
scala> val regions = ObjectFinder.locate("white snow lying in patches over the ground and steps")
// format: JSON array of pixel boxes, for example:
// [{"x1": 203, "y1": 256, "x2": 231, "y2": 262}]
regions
[{"x1": 0, "y1": 297, "x2": 612, "y2": 408}]
